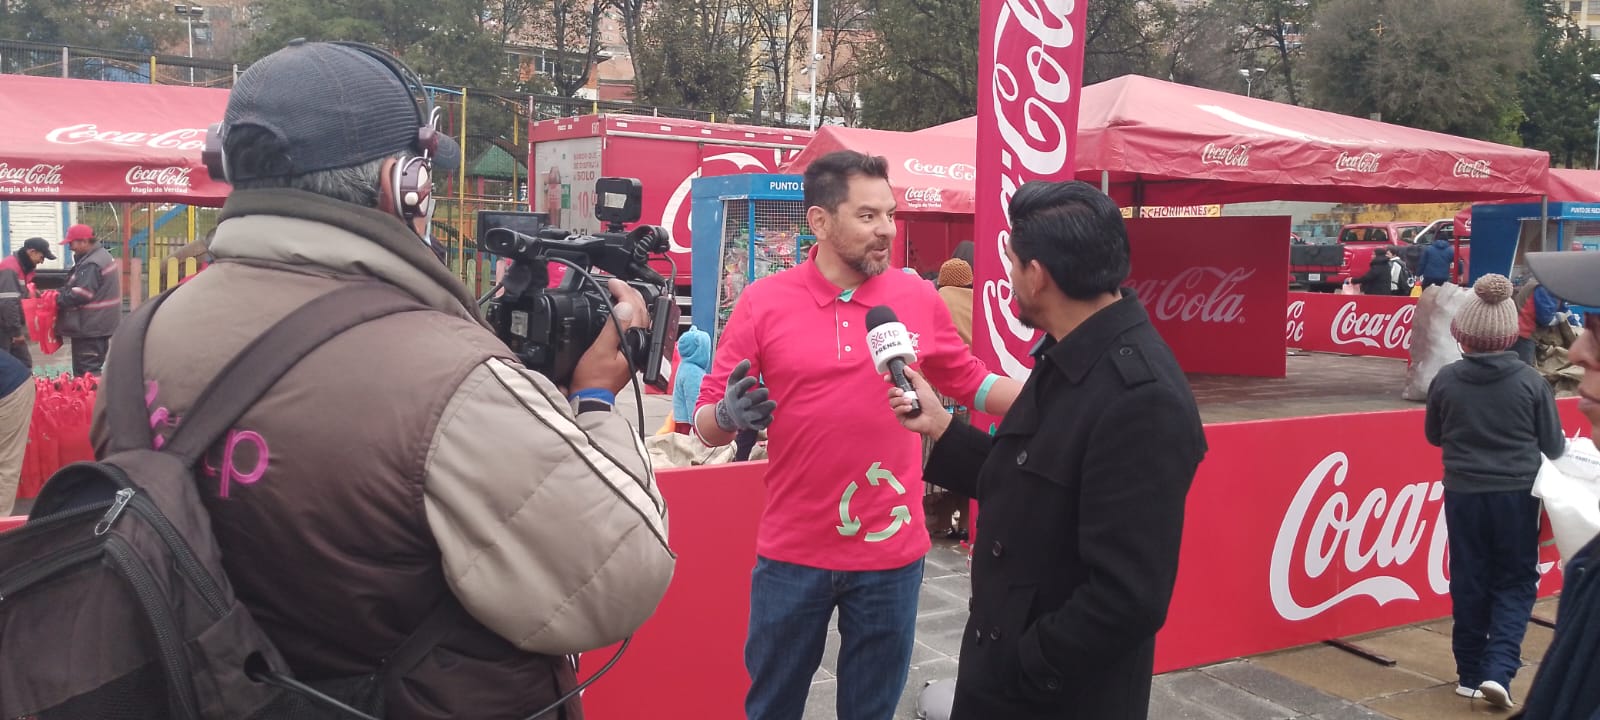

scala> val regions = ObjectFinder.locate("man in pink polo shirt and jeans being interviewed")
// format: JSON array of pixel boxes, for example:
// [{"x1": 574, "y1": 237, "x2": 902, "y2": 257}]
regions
[{"x1": 694, "y1": 150, "x2": 1021, "y2": 720}]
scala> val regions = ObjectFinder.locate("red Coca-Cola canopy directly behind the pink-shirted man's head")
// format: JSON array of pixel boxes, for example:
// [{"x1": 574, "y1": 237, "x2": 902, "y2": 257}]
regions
[{"x1": 784, "y1": 126, "x2": 978, "y2": 214}]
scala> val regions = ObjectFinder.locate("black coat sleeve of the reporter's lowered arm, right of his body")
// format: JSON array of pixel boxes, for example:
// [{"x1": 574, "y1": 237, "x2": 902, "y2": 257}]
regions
[{"x1": 1018, "y1": 382, "x2": 1205, "y2": 688}]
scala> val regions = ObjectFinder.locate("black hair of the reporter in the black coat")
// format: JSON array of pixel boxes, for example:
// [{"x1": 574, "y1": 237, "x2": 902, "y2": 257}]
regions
[{"x1": 1010, "y1": 181, "x2": 1131, "y2": 301}]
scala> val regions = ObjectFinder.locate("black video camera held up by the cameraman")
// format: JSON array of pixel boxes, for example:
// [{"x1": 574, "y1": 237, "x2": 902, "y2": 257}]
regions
[{"x1": 478, "y1": 178, "x2": 678, "y2": 390}]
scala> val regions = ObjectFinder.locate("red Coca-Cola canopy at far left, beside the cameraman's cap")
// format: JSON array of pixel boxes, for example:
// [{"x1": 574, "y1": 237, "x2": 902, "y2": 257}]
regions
[{"x1": 0, "y1": 75, "x2": 230, "y2": 206}]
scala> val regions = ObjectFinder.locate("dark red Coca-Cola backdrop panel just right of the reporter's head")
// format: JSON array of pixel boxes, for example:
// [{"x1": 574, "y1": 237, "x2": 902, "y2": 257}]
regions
[{"x1": 1128, "y1": 218, "x2": 1290, "y2": 378}]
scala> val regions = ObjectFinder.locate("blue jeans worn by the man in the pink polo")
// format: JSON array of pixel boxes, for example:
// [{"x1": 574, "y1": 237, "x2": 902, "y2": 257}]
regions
[{"x1": 744, "y1": 557, "x2": 923, "y2": 720}]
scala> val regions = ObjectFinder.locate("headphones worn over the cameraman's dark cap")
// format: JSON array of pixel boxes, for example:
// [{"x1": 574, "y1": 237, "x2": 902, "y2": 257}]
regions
[{"x1": 200, "y1": 40, "x2": 443, "y2": 224}]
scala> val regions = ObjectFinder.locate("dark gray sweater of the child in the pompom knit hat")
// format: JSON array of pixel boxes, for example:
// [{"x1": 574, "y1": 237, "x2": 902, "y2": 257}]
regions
[{"x1": 1426, "y1": 352, "x2": 1566, "y2": 493}]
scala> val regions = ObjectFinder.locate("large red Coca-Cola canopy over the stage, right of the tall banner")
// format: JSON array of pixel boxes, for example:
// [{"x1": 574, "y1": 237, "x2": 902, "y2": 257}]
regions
[{"x1": 915, "y1": 75, "x2": 1549, "y2": 205}]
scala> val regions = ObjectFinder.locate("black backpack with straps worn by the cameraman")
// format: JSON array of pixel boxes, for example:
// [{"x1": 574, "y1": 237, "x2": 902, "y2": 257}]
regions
[{"x1": 0, "y1": 283, "x2": 432, "y2": 720}]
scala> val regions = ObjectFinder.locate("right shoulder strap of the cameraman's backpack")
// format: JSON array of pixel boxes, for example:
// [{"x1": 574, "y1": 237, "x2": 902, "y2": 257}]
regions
[{"x1": 159, "y1": 283, "x2": 427, "y2": 466}]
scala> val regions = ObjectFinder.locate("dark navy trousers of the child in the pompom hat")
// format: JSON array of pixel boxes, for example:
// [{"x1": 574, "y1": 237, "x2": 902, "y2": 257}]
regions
[{"x1": 1445, "y1": 490, "x2": 1539, "y2": 690}]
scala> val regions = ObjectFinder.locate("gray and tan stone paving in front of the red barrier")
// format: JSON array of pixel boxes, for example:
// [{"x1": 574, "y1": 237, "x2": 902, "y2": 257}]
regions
[{"x1": 805, "y1": 542, "x2": 1555, "y2": 720}]
